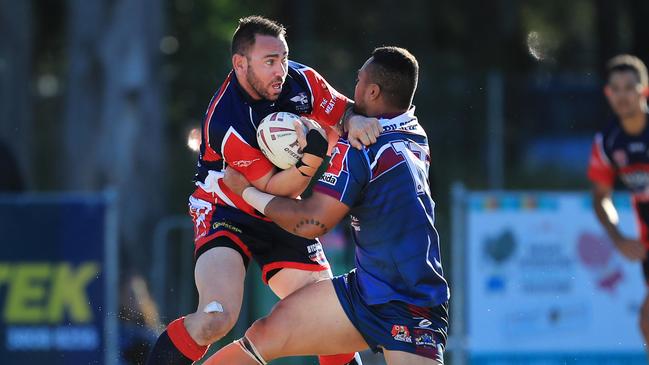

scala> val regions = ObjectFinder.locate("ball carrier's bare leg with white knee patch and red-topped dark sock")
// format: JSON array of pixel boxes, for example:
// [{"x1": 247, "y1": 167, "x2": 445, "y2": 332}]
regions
[{"x1": 147, "y1": 247, "x2": 245, "y2": 365}]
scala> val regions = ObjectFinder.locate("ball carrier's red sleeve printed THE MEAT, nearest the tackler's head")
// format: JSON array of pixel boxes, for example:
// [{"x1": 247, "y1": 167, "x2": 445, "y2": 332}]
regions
[{"x1": 298, "y1": 66, "x2": 349, "y2": 126}]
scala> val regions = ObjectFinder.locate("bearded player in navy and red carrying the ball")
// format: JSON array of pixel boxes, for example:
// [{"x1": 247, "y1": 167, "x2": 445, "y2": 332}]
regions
[{"x1": 144, "y1": 16, "x2": 380, "y2": 364}]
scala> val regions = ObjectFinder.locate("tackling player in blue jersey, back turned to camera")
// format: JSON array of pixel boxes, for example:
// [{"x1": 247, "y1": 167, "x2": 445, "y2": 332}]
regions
[{"x1": 206, "y1": 47, "x2": 449, "y2": 365}]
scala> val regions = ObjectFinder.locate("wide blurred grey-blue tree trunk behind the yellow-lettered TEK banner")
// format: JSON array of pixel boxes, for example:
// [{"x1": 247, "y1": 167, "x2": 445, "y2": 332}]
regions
[{"x1": 63, "y1": 0, "x2": 165, "y2": 265}]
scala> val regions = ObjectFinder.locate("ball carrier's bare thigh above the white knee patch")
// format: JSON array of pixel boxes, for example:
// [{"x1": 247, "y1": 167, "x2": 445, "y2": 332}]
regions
[{"x1": 194, "y1": 247, "x2": 246, "y2": 318}]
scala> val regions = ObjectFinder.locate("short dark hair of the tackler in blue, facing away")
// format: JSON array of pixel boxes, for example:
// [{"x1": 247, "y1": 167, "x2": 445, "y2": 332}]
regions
[{"x1": 368, "y1": 47, "x2": 419, "y2": 109}]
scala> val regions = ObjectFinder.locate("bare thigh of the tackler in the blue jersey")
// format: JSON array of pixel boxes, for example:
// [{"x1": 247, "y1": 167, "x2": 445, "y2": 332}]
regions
[{"x1": 247, "y1": 280, "x2": 368, "y2": 360}]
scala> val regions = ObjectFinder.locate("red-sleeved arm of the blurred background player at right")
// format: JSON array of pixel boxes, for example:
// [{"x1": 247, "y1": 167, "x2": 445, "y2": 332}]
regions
[{"x1": 588, "y1": 134, "x2": 646, "y2": 261}]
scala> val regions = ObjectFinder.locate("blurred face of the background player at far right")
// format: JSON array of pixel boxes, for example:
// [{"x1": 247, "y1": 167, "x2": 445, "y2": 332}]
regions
[{"x1": 606, "y1": 71, "x2": 646, "y2": 118}]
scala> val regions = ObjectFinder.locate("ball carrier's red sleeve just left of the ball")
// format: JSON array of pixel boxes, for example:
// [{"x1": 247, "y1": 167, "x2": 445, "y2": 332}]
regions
[{"x1": 221, "y1": 127, "x2": 274, "y2": 181}]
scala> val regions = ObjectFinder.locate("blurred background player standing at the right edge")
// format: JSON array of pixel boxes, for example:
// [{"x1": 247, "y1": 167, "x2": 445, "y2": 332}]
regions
[{"x1": 588, "y1": 55, "x2": 649, "y2": 358}]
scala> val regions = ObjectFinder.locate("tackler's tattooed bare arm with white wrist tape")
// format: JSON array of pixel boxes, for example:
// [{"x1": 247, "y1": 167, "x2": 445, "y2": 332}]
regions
[{"x1": 225, "y1": 167, "x2": 349, "y2": 238}]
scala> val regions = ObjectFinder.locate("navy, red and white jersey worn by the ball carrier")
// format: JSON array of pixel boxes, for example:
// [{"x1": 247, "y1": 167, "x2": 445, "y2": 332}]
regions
[{"x1": 194, "y1": 61, "x2": 349, "y2": 218}]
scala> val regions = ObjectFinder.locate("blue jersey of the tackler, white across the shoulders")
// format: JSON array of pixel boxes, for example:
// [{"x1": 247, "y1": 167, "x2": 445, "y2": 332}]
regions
[{"x1": 314, "y1": 108, "x2": 449, "y2": 307}]
